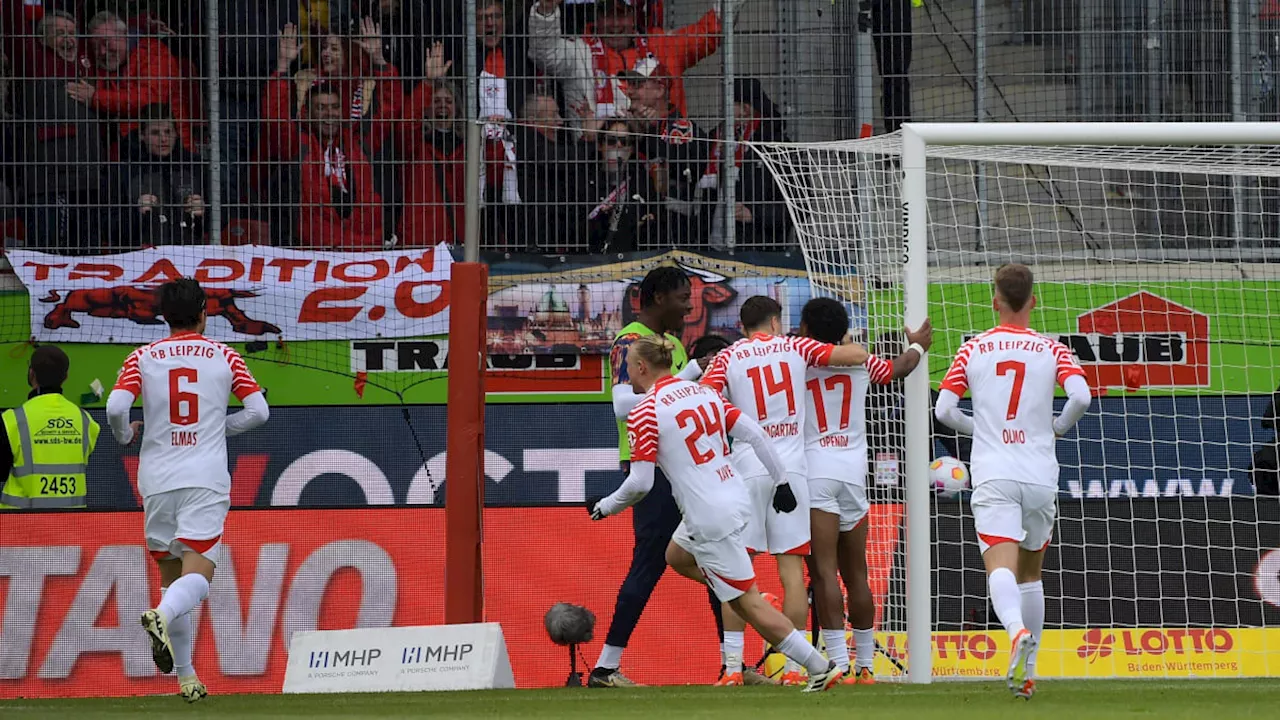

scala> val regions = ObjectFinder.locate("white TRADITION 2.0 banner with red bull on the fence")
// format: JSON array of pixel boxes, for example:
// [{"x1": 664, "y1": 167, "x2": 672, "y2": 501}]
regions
[{"x1": 8, "y1": 245, "x2": 453, "y2": 345}]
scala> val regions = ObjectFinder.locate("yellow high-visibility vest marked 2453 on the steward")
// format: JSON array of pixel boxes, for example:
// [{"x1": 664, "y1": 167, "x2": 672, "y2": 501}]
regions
[{"x1": 0, "y1": 392, "x2": 100, "y2": 510}]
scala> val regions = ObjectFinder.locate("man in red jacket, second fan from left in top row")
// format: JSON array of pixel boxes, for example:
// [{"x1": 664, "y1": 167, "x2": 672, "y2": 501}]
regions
[{"x1": 67, "y1": 12, "x2": 197, "y2": 151}]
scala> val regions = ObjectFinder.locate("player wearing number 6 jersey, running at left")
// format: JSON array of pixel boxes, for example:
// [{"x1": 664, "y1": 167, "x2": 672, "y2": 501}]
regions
[{"x1": 106, "y1": 278, "x2": 269, "y2": 702}]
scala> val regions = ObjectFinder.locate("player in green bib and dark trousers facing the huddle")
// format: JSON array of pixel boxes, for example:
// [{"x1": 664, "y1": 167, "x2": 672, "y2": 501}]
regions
[{"x1": 586, "y1": 265, "x2": 721, "y2": 688}]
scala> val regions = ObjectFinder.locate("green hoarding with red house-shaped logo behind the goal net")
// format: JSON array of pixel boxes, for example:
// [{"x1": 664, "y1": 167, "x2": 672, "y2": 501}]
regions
[{"x1": 929, "y1": 281, "x2": 1280, "y2": 395}]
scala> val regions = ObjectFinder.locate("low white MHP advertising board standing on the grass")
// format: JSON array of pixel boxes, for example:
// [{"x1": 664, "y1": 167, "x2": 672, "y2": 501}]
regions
[{"x1": 283, "y1": 623, "x2": 516, "y2": 693}]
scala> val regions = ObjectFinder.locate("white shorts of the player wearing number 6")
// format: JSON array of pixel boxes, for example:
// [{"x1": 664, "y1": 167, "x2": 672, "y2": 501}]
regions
[{"x1": 142, "y1": 488, "x2": 232, "y2": 565}]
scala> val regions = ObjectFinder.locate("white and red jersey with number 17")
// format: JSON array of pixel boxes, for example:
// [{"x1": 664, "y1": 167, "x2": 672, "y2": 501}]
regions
[{"x1": 804, "y1": 355, "x2": 893, "y2": 487}]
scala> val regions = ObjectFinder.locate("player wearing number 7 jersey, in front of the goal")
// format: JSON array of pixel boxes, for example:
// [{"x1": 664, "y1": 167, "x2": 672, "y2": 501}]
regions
[{"x1": 934, "y1": 265, "x2": 1089, "y2": 698}]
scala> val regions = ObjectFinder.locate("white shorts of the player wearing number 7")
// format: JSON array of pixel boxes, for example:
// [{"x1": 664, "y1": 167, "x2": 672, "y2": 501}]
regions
[{"x1": 969, "y1": 480, "x2": 1057, "y2": 552}]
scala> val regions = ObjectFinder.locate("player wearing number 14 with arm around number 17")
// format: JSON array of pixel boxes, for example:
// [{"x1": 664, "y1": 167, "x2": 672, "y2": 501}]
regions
[{"x1": 703, "y1": 295, "x2": 890, "y2": 685}]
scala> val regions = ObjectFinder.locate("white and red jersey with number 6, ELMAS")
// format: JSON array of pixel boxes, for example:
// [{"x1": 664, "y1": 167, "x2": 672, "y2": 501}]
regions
[{"x1": 115, "y1": 333, "x2": 261, "y2": 497}]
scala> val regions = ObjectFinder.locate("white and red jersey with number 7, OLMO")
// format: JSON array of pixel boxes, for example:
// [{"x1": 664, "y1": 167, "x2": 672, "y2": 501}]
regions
[{"x1": 942, "y1": 325, "x2": 1084, "y2": 488}]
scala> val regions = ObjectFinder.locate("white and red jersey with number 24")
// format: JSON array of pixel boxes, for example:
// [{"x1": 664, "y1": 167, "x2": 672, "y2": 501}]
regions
[{"x1": 627, "y1": 375, "x2": 750, "y2": 541}]
